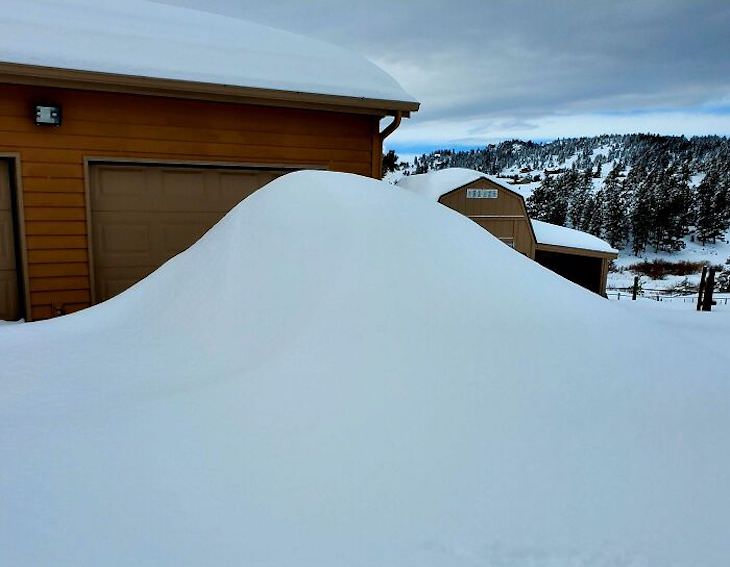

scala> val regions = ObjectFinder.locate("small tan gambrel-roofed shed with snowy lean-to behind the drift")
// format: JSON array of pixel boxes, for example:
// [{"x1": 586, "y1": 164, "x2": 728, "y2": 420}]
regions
[{"x1": 397, "y1": 168, "x2": 618, "y2": 296}]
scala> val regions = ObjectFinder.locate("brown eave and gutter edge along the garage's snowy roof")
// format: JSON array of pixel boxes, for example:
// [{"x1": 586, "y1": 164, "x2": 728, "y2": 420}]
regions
[{"x1": 0, "y1": 62, "x2": 420, "y2": 118}]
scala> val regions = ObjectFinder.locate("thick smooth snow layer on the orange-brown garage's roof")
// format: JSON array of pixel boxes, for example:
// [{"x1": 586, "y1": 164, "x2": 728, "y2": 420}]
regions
[{"x1": 0, "y1": 0, "x2": 413, "y2": 101}]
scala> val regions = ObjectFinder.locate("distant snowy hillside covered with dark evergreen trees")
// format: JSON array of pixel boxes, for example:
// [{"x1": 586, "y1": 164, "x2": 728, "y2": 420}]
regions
[{"x1": 386, "y1": 134, "x2": 730, "y2": 255}]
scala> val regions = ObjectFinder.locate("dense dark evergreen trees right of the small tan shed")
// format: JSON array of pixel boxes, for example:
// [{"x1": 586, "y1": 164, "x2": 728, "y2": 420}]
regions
[{"x1": 526, "y1": 160, "x2": 730, "y2": 254}]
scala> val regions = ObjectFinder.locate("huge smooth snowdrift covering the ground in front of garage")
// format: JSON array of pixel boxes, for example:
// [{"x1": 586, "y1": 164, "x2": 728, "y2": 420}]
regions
[{"x1": 0, "y1": 172, "x2": 730, "y2": 567}]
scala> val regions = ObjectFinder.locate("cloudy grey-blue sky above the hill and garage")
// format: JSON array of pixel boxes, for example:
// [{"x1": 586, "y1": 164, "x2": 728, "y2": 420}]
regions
[{"x1": 159, "y1": 0, "x2": 730, "y2": 154}]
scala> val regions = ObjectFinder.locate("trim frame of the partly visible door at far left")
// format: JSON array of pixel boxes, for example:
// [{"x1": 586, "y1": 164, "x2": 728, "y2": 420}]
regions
[{"x1": 0, "y1": 152, "x2": 33, "y2": 322}]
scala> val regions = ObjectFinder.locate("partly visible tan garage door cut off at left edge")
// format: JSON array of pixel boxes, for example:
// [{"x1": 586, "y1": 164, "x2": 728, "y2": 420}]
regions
[{"x1": 0, "y1": 161, "x2": 20, "y2": 321}]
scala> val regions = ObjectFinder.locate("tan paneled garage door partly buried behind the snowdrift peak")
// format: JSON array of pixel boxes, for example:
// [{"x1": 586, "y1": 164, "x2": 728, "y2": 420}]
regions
[{"x1": 90, "y1": 164, "x2": 286, "y2": 302}]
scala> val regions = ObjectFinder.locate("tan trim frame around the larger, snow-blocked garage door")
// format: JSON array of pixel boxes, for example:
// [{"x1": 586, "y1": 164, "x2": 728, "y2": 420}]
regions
[{"x1": 84, "y1": 156, "x2": 329, "y2": 305}]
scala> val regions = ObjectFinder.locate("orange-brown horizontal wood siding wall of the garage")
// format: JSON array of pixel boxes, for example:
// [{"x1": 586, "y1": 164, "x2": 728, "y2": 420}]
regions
[{"x1": 0, "y1": 84, "x2": 381, "y2": 319}]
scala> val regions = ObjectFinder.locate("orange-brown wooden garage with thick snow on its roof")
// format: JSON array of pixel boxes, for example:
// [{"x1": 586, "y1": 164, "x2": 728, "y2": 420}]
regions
[{"x1": 0, "y1": 0, "x2": 419, "y2": 320}]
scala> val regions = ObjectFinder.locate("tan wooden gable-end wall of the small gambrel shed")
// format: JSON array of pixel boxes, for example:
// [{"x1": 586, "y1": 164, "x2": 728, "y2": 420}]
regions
[{"x1": 439, "y1": 179, "x2": 535, "y2": 258}]
